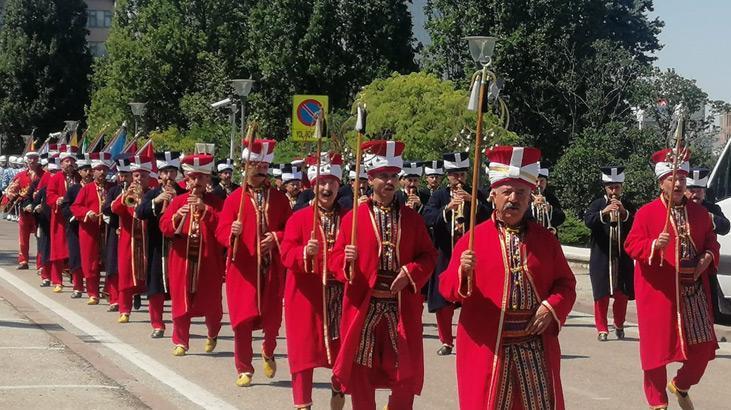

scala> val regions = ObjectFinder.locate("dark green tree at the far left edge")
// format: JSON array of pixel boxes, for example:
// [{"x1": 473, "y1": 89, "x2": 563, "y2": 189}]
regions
[{"x1": 0, "y1": 0, "x2": 91, "y2": 149}]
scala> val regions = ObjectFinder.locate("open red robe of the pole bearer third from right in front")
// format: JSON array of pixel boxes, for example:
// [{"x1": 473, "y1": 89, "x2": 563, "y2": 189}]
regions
[{"x1": 330, "y1": 202, "x2": 437, "y2": 394}]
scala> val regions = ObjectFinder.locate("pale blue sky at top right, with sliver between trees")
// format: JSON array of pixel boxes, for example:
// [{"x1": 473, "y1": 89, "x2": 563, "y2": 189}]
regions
[{"x1": 412, "y1": 0, "x2": 731, "y2": 102}]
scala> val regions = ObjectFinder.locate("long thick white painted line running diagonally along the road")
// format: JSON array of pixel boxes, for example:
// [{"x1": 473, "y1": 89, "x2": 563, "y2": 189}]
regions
[{"x1": 0, "y1": 268, "x2": 236, "y2": 409}]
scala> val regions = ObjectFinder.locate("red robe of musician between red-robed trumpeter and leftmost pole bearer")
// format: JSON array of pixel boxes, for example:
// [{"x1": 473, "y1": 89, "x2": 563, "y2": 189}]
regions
[{"x1": 160, "y1": 192, "x2": 225, "y2": 319}]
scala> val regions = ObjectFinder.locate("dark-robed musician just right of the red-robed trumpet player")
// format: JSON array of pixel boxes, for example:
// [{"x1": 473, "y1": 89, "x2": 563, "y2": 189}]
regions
[{"x1": 135, "y1": 151, "x2": 187, "y2": 338}]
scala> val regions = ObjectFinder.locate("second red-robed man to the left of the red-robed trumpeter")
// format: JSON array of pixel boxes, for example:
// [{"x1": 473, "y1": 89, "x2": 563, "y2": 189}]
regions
[{"x1": 46, "y1": 145, "x2": 84, "y2": 293}]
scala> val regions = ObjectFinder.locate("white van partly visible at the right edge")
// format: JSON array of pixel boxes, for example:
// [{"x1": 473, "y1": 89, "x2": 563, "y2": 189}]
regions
[{"x1": 708, "y1": 140, "x2": 731, "y2": 325}]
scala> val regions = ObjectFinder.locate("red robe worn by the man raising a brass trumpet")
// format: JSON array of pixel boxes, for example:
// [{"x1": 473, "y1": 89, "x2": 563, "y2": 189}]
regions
[{"x1": 111, "y1": 191, "x2": 147, "y2": 292}]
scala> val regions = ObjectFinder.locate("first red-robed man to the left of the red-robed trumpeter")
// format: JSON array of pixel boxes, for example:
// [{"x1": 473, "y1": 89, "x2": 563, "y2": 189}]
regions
[{"x1": 71, "y1": 152, "x2": 112, "y2": 305}]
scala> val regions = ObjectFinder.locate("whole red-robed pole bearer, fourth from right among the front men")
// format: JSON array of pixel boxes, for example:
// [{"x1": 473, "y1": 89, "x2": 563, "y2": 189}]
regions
[{"x1": 282, "y1": 152, "x2": 346, "y2": 409}]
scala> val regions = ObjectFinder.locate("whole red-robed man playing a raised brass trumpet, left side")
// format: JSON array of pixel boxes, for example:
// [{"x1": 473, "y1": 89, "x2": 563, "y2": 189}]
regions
[{"x1": 111, "y1": 155, "x2": 154, "y2": 323}]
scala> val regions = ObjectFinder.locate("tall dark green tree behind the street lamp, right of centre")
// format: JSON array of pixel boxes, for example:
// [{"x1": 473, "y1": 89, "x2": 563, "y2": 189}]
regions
[{"x1": 426, "y1": 0, "x2": 662, "y2": 160}]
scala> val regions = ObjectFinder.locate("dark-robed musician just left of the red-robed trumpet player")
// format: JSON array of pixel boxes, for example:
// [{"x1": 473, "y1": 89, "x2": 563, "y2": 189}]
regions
[{"x1": 102, "y1": 157, "x2": 132, "y2": 312}]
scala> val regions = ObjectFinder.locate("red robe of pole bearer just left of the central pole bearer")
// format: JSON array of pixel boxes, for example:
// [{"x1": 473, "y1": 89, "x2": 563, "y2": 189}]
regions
[{"x1": 282, "y1": 206, "x2": 347, "y2": 374}]
